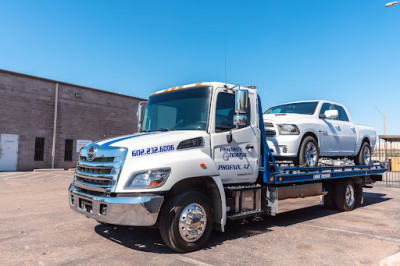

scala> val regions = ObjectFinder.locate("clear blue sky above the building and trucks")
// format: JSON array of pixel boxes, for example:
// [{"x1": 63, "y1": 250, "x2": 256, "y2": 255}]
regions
[{"x1": 0, "y1": 0, "x2": 400, "y2": 134}]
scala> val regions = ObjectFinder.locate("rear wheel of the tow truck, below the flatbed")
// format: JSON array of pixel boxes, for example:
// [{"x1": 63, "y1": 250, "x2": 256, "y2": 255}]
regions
[{"x1": 335, "y1": 179, "x2": 357, "y2": 211}]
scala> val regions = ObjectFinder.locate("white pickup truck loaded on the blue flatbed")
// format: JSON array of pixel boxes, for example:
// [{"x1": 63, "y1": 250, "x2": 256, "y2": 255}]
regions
[{"x1": 263, "y1": 100, "x2": 376, "y2": 167}]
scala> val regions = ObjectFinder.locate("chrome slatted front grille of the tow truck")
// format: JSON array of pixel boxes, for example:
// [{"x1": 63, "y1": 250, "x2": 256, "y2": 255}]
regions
[{"x1": 72, "y1": 145, "x2": 127, "y2": 197}]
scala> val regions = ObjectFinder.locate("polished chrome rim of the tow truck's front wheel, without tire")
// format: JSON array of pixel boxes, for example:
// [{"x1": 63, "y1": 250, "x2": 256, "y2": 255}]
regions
[{"x1": 179, "y1": 203, "x2": 207, "y2": 242}]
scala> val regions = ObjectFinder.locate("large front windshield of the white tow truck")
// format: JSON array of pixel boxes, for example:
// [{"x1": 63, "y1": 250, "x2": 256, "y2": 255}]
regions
[{"x1": 142, "y1": 87, "x2": 211, "y2": 131}]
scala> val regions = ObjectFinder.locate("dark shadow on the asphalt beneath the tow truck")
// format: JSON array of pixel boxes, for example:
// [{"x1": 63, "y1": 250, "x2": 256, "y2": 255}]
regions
[{"x1": 94, "y1": 192, "x2": 391, "y2": 254}]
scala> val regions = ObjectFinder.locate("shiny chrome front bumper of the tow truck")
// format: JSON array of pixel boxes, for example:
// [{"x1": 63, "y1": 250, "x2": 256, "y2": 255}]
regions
[{"x1": 69, "y1": 185, "x2": 164, "y2": 226}]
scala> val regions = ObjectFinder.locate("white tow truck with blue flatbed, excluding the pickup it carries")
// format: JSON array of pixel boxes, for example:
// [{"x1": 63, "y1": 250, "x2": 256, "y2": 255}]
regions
[{"x1": 69, "y1": 82, "x2": 386, "y2": 252}]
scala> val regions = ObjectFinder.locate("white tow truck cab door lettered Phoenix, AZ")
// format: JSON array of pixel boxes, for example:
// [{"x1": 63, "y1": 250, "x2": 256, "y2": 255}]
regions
[{"x1": 211, "y1": 88, "x2": 260, "y2": 183}]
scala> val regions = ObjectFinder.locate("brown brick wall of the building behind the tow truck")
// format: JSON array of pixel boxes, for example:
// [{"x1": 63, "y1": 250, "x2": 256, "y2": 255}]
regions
[{"x1": 0, "y1": 70, "x2": 144, "y2": 170}]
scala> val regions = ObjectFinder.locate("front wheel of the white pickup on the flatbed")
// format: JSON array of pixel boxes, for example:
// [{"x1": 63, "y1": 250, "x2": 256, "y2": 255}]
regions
[{"x1": 294, "y1": 136, "x2": 319, "y2": 167}]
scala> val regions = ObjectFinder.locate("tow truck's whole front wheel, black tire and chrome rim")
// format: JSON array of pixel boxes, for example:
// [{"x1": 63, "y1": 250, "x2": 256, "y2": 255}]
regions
[{"x1": 160, "y1": 191, "x2": 213, "y2": 253}]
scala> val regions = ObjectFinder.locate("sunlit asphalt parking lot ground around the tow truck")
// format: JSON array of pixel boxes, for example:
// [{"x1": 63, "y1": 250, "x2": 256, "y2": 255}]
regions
[{"x1": 0, "y1": 171, "x2": 400, "y2": 265}]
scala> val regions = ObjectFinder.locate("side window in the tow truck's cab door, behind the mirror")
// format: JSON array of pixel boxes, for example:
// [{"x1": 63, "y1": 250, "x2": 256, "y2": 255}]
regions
[{"x1": 215, "y1": 92, "x2": 251, "y2": 132}]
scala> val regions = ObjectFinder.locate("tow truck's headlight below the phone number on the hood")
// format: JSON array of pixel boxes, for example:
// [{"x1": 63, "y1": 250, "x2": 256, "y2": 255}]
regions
[{"x1": 126, "y1": 168, "x2": 171, "y2": 188}]
